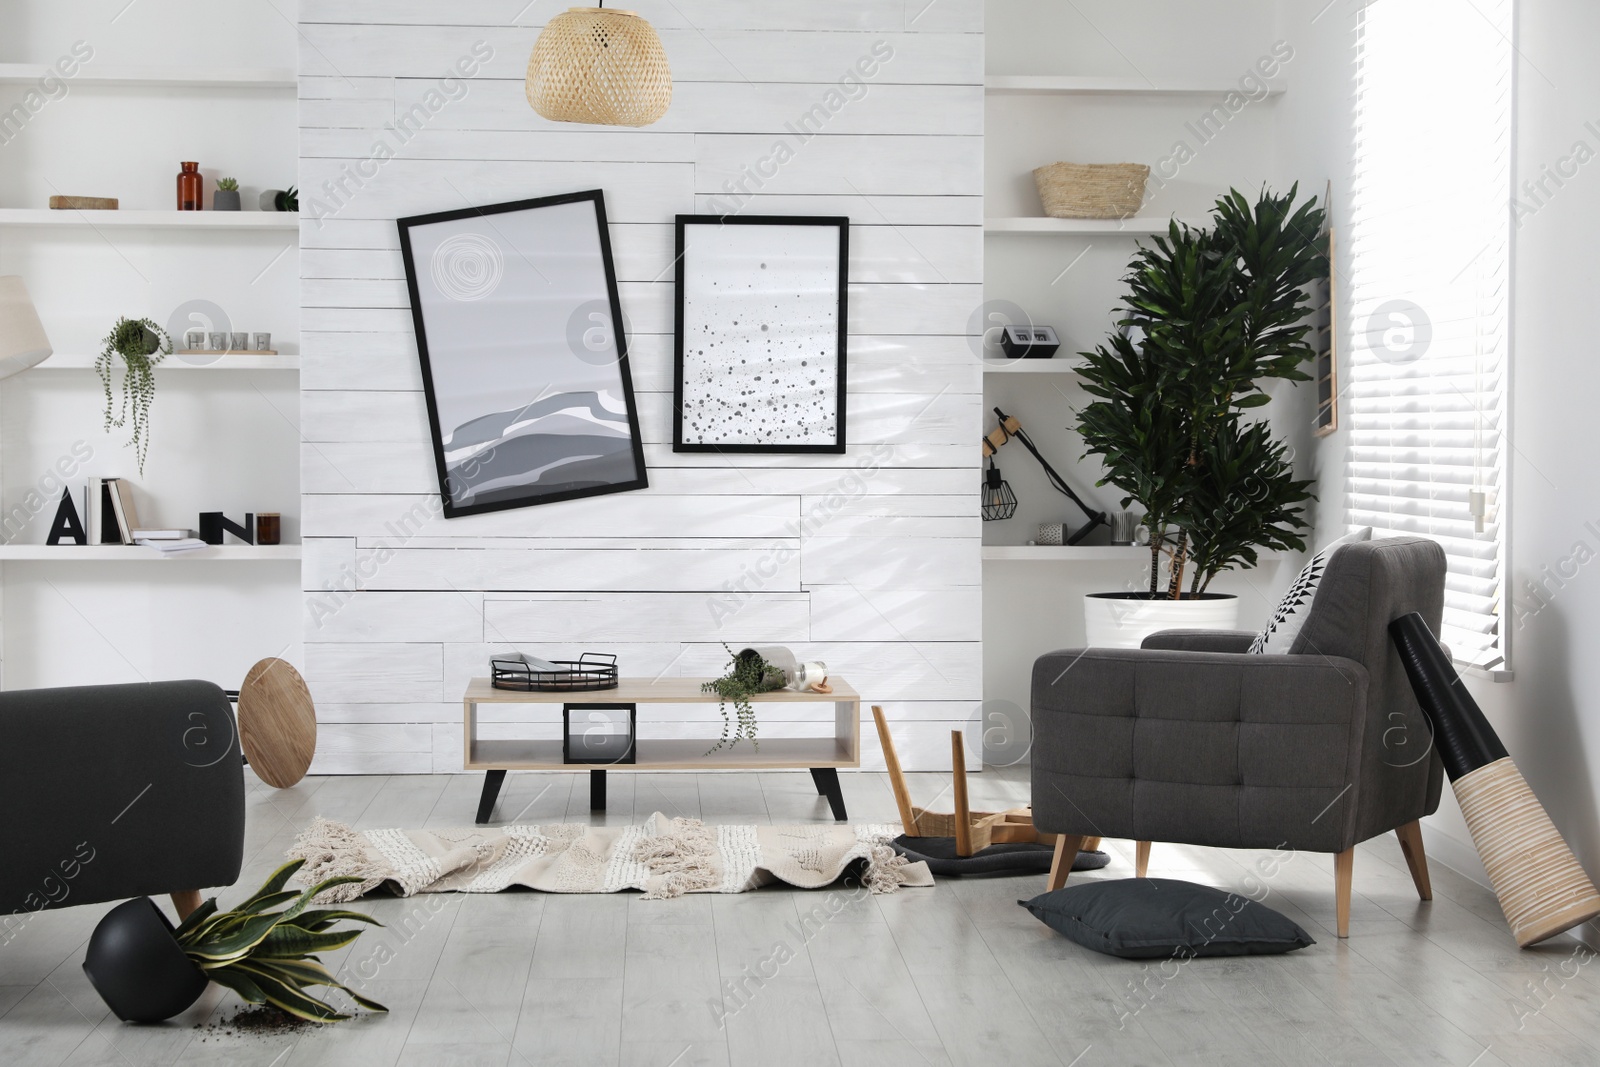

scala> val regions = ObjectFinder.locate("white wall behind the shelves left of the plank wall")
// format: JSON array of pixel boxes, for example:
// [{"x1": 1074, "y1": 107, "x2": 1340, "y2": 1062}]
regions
[{"x1": 0, "y1": 0, "x2": 302, "y2": 688}]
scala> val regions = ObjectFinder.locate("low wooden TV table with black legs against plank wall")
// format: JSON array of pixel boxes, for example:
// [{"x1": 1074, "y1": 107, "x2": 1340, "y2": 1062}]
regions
[{"x1": 461, "y1": 677, "x2": 861, "y2": 824}]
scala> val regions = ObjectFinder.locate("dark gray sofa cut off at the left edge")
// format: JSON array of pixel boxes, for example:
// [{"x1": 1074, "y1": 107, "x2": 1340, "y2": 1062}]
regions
[{"x1": 0, "y1": 681, "x2": 245, "y2": 941}]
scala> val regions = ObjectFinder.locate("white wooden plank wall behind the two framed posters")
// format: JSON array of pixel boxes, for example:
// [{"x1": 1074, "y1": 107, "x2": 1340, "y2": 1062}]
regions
[{"x1": 299, "y1": 0, "x2": 984, "y2": 774}]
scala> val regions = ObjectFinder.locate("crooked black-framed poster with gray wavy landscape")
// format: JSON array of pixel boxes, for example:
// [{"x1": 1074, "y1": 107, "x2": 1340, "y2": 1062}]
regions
[{"x1": 398, "y1": 189, "x2": 648, "y2": 518}]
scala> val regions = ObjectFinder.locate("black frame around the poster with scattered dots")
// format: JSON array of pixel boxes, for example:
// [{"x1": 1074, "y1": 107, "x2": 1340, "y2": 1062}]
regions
[{"x1": 672, "y1": 214, "x2": 850, "y2": 456}]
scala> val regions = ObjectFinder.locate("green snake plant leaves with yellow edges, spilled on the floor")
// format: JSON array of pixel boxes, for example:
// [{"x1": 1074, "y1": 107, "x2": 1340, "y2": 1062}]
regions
[{"x1": 174, "y1": 859, "x2": 389, "y2": 1022}]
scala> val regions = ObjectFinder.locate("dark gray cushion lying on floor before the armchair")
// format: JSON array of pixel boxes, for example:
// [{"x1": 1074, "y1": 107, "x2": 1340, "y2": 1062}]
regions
[{"x1": 1018, "y1": 878, "x2": 1317, "y2": 960}]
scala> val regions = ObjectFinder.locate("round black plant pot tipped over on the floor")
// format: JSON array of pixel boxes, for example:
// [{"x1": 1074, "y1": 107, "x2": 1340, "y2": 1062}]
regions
[{"x1": 83, "y1": 896, "x2": 208, "y2": 1022}]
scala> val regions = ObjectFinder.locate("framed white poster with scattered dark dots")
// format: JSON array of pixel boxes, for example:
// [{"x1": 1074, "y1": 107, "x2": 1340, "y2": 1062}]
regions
[{"x1": 672, "y1": 214, "x2": 850, "y2": 453}]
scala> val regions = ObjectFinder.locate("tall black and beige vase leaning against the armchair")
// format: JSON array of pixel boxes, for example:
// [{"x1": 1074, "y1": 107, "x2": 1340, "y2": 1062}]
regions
[{"x1": 1389, "y1": 611, "x2": 1600, "y2": 949}]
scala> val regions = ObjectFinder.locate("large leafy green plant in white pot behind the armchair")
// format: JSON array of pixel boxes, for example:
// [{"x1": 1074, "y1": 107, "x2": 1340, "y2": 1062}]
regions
[{"x1": 1078, "y1": 186, "x2": 1328, "y2": 646}]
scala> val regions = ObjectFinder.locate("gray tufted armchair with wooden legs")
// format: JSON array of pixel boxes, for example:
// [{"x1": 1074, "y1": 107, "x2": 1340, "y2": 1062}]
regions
[{"x1": 1032, "y1": 537, "x2": 1445, "y2": 937}]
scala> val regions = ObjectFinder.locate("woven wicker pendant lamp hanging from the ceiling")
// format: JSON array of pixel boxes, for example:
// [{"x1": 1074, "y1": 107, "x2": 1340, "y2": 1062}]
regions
[{"x1": 526, "y1": 8, "x2": 672, "y2": 126}]
